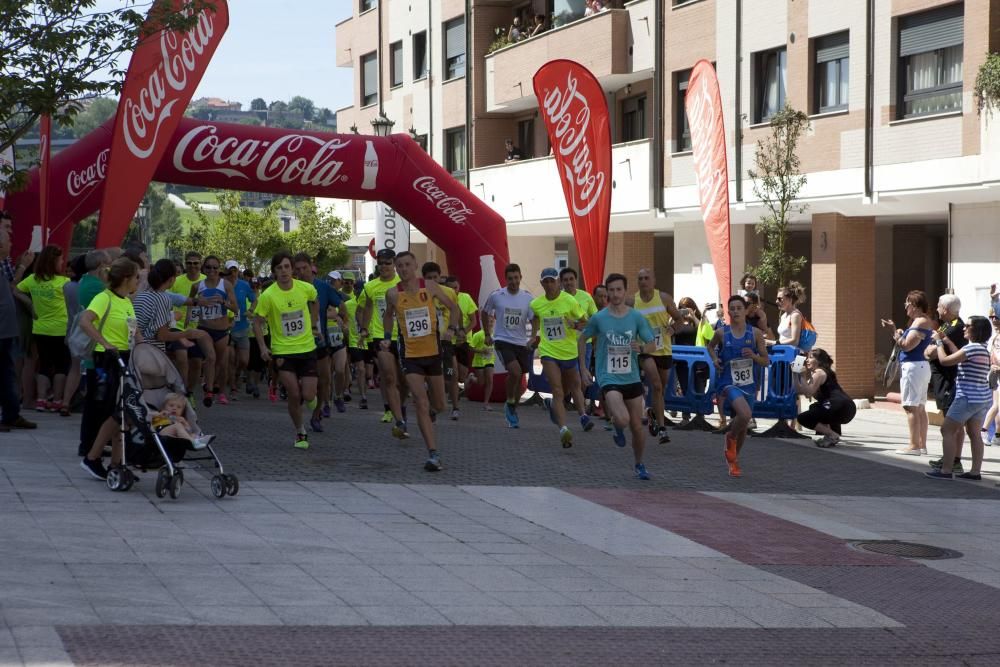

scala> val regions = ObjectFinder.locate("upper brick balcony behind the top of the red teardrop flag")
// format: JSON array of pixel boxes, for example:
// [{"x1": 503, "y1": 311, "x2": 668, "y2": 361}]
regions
[{"x1": 485, "y1": 6, "x2": 636, "y2": 113}]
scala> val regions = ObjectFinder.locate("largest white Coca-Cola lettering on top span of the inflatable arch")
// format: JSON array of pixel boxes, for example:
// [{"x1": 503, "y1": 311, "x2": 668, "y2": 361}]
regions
[{"x1": 173, "y1": 125, "x2": 351, "y2": 187}]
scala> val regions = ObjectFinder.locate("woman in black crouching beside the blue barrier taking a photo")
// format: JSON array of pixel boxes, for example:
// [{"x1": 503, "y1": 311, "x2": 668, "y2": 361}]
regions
[{"x1": 793, "y1": 347, "x2": 857, "y2": 447}]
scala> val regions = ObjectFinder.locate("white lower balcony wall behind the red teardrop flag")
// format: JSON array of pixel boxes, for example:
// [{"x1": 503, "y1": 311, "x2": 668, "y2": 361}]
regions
[{"x1": 469, "y1": 139, "x2": 651, "y2": 234}]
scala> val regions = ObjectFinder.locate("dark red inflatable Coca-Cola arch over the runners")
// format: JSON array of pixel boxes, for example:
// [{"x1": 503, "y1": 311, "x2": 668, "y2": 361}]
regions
[{"x1": 7, "y1": 118, "x2": 509, "y2": 304}]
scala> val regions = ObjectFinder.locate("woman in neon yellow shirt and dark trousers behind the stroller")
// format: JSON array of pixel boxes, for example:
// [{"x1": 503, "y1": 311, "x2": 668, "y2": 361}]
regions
[{"x1": 79, "y1": 257, "x2": 142, "y2": 479}]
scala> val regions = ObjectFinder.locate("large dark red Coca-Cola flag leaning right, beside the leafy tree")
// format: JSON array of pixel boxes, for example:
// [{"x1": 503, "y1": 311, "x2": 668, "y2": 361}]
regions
[{"x1": 97, "y1": 0, "x2": 229, "y2": 248}]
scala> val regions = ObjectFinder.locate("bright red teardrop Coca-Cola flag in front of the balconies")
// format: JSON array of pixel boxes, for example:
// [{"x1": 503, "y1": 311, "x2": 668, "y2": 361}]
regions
[{"x1": 533, "y1": 60, "x2": 611, "y2": 289}]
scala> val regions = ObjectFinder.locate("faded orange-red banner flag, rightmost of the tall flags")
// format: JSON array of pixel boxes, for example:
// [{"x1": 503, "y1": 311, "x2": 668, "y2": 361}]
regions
[{"x1": 684, "y1": 60, "x2": 733, "y2": 300}]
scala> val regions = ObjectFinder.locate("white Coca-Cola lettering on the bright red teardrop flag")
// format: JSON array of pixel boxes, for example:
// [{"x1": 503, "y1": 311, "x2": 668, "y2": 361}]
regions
[{"x1": 542, "y1": 72, "x2": 611, "y2": 216}]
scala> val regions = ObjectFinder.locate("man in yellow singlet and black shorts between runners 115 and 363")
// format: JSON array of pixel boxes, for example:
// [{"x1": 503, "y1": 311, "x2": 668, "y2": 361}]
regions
[{"x1": 626, "y1": 269, "x2": 687, "y2": 444}]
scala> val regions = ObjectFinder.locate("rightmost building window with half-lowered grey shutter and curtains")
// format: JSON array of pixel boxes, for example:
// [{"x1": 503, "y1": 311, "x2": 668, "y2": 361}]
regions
[{"x1": 896, "y1": 3, "x2": 964, "y2": 118}]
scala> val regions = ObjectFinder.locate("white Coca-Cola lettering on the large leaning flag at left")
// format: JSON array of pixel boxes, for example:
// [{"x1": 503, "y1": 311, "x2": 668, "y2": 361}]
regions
[{"x1": 121, "y1": 9, "x2": 215, "y2": 159}]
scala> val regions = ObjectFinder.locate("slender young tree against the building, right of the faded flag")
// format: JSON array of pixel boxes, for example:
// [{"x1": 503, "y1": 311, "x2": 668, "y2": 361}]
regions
[{"x1": 747, "y1": 105, "x2": 809, "y2": 285}]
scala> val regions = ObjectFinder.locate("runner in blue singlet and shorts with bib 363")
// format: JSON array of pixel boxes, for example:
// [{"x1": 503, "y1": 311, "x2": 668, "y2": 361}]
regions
[{"x1": 708, "y1": 294, "x2": 770, "y2": 477}]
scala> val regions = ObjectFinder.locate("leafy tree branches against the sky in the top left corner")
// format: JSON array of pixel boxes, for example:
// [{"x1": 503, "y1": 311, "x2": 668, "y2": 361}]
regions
[{"x1": 0, "y1": 0, "x2": 214, "y2": 155}]
